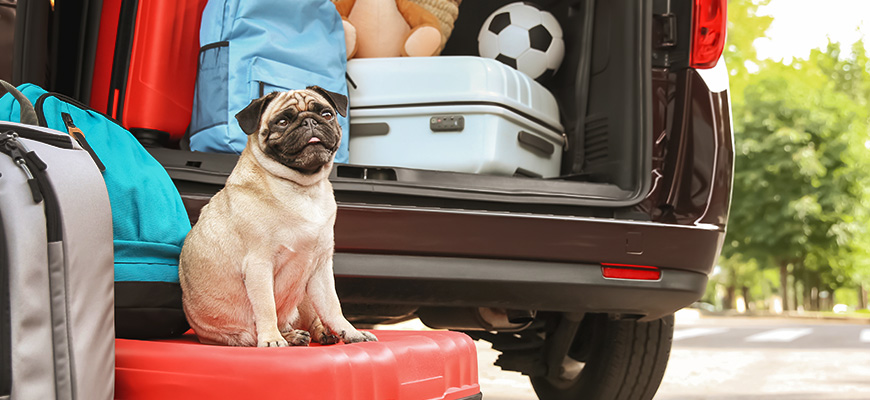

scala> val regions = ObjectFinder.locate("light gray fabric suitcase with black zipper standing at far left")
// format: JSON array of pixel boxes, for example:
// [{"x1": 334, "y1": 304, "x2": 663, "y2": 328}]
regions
[{"x1": 0, "y1": 82, "x2": 115, "y2": 400}]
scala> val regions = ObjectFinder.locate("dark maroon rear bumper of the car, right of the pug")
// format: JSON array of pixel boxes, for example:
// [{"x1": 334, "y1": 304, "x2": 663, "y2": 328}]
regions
[{"x1": 335, "y1": 203, "x2": 724, "y2": 319}]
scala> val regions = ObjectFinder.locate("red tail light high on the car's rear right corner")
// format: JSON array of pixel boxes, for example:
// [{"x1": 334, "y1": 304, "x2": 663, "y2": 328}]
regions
[{"x1": 690, "y1": 0, "x2": 728, "y2": 68}]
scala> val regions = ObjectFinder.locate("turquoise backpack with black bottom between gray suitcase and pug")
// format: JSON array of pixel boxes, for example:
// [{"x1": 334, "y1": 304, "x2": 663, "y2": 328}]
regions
[{"x1": 0, "y1": 84, "x2": 190, "y2": 339}]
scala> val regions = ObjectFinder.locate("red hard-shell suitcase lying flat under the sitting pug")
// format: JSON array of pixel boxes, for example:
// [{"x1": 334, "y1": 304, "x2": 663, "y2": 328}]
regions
[{"x1": 115, "y1": 331, "x2": 482, "y2": 400}]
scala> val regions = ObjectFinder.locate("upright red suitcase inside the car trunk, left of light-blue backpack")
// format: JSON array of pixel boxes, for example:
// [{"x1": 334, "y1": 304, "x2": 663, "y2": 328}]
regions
[{"x1": 90, "y1": 0, "x2": 207, "y2": 142}]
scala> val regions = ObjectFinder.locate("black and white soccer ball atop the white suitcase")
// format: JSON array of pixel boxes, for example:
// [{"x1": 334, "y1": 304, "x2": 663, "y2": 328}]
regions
[{"x1": 477, "y1": 2, "x2": 565, "y2": 79}]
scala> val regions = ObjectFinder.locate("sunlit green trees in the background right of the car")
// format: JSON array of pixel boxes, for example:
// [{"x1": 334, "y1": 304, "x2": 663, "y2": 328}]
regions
[{"x1": 704, "y1": 0, "x2": 870, "y2": 310}]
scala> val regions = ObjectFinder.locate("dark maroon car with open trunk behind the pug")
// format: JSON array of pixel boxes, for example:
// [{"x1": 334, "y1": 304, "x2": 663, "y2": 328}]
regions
[{"x1": 13, "y1": 0, "x2": 734, "y2": 400}]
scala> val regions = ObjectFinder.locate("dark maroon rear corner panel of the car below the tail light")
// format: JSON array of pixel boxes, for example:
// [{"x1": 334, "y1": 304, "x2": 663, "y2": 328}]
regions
[{"x1": 636, "y1": 63, "x2": 734, "y2": 228}]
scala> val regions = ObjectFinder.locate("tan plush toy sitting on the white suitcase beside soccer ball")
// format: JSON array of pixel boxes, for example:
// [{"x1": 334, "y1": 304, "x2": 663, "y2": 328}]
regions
[{"x1": 333, "y1": 0, "x2": 442, "y2": 59}]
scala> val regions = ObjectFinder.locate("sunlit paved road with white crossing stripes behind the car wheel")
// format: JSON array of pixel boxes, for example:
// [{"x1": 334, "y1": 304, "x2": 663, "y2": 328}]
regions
[{"x1": 478, "y1": 318, "x2": 870, "y2": 400}]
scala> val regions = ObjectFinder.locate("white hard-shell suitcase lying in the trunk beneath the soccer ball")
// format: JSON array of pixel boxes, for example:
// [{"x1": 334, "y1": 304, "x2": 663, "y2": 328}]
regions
[{"x1": 347, "y1": 56, "x2": 564, "y2": 178}]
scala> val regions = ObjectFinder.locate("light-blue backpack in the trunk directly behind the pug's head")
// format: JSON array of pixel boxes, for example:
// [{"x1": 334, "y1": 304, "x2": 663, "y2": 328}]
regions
[{"x1": 190, "y1": 0, "x2": 348, "y2": 163}]
